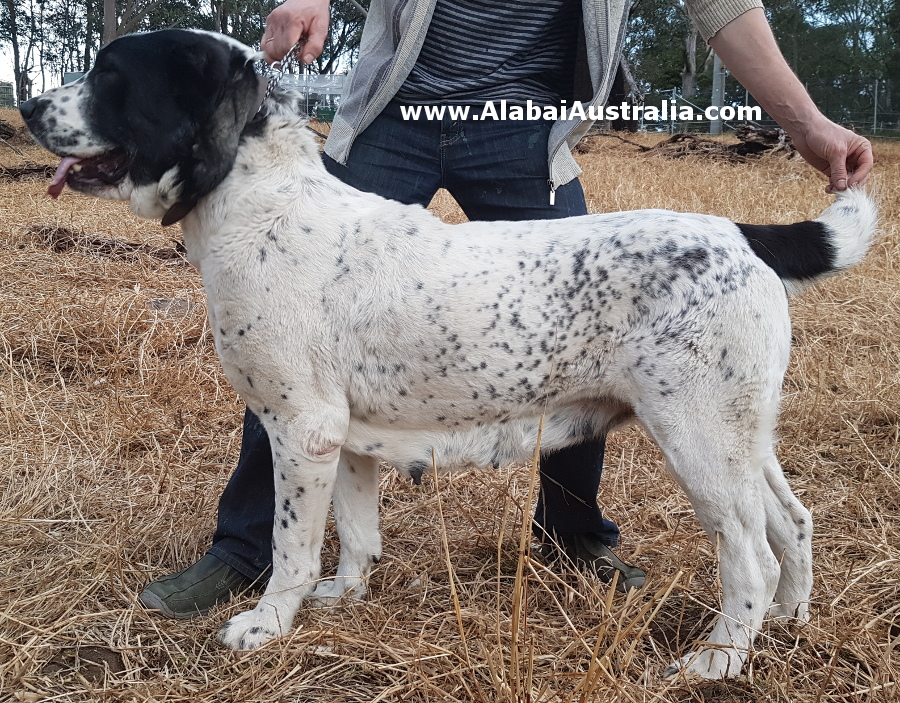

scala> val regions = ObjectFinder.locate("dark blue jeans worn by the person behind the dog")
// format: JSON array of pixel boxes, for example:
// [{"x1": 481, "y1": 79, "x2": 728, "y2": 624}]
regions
[{"x1": 209, "y1": 103, "x2": 619, "y2": 579}]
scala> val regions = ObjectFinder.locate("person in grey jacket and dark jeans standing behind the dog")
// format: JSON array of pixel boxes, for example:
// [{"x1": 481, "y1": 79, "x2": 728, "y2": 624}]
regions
[{"x1": 140, "y1": 0, "x2": 872, "y2": 617}]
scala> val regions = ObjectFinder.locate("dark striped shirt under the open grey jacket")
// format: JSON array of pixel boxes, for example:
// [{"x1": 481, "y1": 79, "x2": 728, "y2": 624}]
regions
[{"x1": 397, "y1": 0, "x2": 581, "y2": 105}]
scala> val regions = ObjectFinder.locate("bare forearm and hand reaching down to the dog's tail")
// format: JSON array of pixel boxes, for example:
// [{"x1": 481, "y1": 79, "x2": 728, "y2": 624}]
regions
[{"x1": 709, "y1": 8, "x2": 873, "y2": 193}]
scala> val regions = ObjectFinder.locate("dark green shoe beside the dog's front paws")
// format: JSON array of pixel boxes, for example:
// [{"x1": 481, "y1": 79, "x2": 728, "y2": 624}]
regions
[{"x1": 138, "y1": 554, "x2": 259, "y2": 619}]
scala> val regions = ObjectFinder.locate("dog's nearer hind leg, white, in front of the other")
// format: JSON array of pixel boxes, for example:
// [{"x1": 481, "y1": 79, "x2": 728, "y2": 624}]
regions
[{"x1": 638, "y1": 402, "x2": 779, "y2": 678}]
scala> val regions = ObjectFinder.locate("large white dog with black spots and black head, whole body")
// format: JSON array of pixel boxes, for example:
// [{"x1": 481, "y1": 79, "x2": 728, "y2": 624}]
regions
[{"x1": 22, "y1": 30, "x2": 876, "y2": 678}]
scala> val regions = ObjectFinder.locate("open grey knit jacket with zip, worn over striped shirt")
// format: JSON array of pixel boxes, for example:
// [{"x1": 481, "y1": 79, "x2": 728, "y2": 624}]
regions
[{"x1": 325, "y1": 0, "x2": 762, "y2": 190}]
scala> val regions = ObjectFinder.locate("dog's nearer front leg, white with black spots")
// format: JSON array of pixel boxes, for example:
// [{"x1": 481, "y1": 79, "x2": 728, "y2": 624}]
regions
[{"x1": 219, "y1": 418, "x2": 340, "y2": 649}]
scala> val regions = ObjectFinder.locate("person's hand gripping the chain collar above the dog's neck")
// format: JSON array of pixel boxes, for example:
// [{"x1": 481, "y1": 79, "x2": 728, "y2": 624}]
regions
[{"x1": 262, "y1": 0, "x2": 329, "y2": 64}]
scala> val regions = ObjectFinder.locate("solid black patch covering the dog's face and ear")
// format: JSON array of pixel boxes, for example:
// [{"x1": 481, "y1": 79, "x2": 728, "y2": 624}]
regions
[{"x1": 85, "y1": 30, "x2": 265, "y2": 224}]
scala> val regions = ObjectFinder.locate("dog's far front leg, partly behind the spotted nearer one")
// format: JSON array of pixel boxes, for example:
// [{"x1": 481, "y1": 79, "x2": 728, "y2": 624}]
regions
[{"x1": 313, "y1": 449, "x2": 381, "y2": 605}]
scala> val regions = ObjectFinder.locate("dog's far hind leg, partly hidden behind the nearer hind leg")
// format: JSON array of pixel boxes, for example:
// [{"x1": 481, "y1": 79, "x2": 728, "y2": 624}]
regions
[{"x1": 763, "y1": 450, "x2": 813, "y2": 622}]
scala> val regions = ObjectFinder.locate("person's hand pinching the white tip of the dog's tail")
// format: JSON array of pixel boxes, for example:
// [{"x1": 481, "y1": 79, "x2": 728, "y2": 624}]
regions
[{"x1": 791, "y1": 116, "x2": 874, "y2": 193}]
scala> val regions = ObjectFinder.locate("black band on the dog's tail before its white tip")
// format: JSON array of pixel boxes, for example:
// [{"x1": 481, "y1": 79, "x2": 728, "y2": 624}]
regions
[{"x1": 735, "y1": 221, "x2": 835, "y2": 281}]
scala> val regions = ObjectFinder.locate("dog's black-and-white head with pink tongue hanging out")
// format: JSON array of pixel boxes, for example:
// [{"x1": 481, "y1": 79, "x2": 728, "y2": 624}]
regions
[{"x1": 21, "y1": 30, "x2": 265, "y2": 224}]
